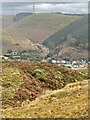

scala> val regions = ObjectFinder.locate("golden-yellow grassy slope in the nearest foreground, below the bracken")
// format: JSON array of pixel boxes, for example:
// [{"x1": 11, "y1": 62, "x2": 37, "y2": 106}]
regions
[{"x1": 2, "y1": 80, "x2": 89, "y2": 117}]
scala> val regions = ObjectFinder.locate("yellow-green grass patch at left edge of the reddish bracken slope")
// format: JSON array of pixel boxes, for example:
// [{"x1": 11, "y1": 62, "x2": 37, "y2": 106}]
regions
[{"x1": 2, "y1": 67, "x2": 23, "y2": 100}]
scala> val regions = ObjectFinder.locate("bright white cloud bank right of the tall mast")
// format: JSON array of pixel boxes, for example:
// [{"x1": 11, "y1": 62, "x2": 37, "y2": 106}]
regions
[{"x1": 23, "y1": 3, "x2": 88, "y2": 14}]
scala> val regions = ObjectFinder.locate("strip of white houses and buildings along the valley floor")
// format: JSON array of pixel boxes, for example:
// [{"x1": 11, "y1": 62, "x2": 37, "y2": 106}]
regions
[{"x1": 0, "y1": 52, "x2": 90, "y2": 69}]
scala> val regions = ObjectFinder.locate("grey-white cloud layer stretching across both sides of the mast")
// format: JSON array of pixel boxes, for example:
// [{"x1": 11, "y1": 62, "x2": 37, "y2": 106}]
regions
[{"x1": 2, "y1": 0, "x2": 88, "y2": 14}]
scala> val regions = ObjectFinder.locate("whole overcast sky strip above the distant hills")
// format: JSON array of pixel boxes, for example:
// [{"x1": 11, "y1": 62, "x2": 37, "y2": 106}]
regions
[{"x1": 0, "y1": 0, "x2": 88, "y2": 14}]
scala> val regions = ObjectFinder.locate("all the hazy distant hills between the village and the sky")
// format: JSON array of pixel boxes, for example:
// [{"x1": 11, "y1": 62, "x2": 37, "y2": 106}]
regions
[{"x1": 2, "y1": 13, "x2": 89, "y2": 60}]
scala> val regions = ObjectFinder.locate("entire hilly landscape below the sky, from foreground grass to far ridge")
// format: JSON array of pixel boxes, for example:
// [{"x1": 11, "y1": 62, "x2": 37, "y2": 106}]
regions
[{"x1": 0, "y1": 10, "x2": 90, "y2": 120}]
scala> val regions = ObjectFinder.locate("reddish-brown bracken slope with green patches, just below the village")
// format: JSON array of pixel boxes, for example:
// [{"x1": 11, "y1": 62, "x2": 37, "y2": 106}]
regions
[{"x1": 2, "y1": 62, "x2": 88, "y2": 108}]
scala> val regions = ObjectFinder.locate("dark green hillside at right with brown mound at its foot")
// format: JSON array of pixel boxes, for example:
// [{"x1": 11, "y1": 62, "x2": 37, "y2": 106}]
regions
[{"x1": 43, "y1": 16, "x2": 88, "y2": 59}]
